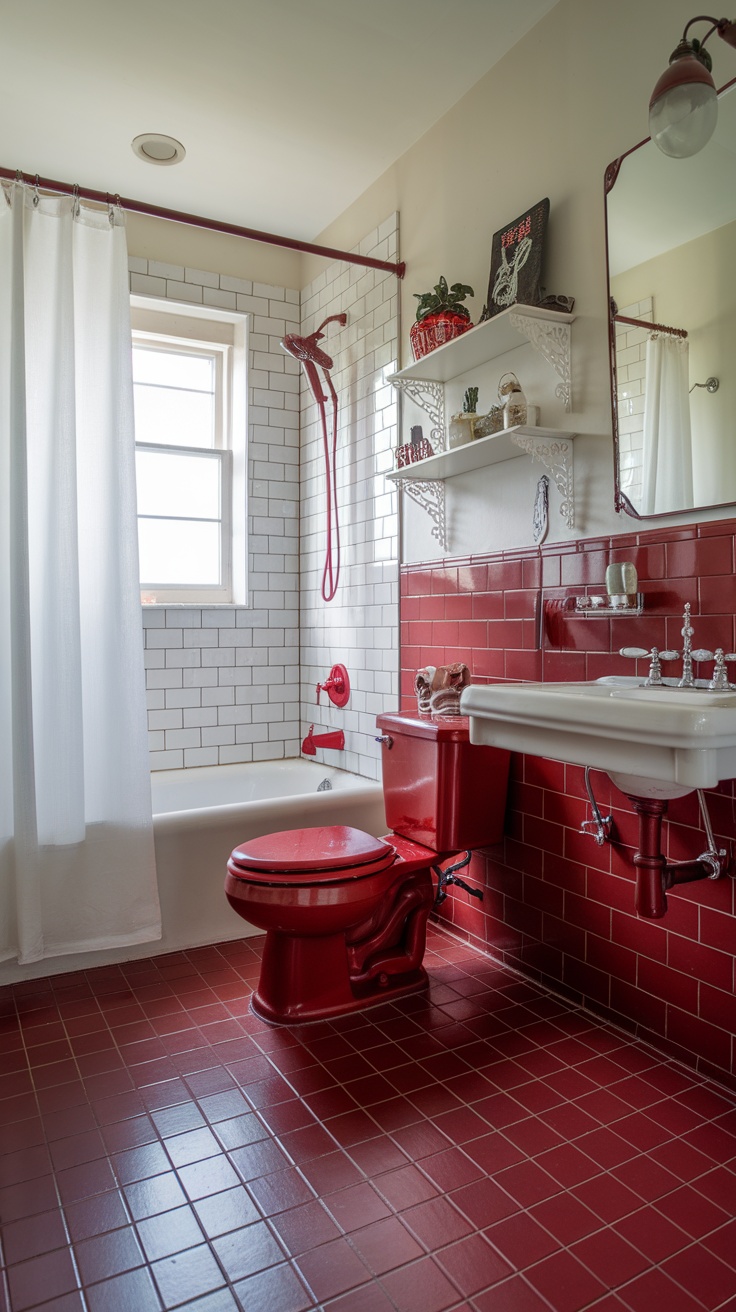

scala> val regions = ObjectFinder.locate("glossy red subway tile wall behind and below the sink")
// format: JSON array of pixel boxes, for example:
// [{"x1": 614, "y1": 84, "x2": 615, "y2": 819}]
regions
[{"x1": 401, "y1": 520, "x2": 736, "y2": 1088}]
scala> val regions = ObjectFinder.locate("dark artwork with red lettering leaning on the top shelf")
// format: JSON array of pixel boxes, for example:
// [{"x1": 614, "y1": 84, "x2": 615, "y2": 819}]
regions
[{"x1": 481, "y1": 197, "x2": 550, "y2": 319}]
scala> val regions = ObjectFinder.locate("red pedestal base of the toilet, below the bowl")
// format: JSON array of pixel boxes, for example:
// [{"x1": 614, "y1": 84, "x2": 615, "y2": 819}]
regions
[{"x1": 251, "y1": 866, "x2": 434, "y2": 1025}]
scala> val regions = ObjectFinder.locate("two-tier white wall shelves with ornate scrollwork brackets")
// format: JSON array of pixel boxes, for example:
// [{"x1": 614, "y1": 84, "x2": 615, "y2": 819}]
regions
[{"x1": 387, "y1": 304, "x2": 575, "y2": 551}]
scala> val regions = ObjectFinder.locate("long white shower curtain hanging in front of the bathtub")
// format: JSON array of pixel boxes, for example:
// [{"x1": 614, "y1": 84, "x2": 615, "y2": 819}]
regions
[{"x1": 0, "y1": 184, "x2": 160, "y2": 964}]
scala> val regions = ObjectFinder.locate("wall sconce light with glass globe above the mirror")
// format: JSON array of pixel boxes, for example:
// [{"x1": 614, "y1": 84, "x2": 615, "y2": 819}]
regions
[{"x1": 649, "y1": 14, "x2": 736, "y2": 159}]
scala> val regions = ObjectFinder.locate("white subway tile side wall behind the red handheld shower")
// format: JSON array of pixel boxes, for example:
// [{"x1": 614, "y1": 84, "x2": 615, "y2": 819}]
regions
[{"x1": 300, "y1": 214, "x2": 399, "y2": 779}]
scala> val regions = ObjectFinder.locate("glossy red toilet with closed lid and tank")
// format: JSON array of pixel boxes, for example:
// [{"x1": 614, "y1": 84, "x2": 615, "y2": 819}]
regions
[{"x1": 224, "y1": 714, "x2": 509, "y2": 1025}]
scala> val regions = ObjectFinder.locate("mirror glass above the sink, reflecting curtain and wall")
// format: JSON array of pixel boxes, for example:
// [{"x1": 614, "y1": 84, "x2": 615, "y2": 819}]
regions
[{"x1": 606, "y1": 75, "x2": 736, "y2": 517}]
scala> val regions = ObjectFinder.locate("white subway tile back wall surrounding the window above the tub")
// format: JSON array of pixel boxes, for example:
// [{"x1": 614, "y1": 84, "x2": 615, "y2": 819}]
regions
[{"x1": 129, "y1": 257, "x2": 300, "y2": 770}]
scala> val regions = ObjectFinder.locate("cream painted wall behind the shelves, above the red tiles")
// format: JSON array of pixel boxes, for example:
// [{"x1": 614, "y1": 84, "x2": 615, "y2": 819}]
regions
[{"x1": 304, "y1": 0, "x2": 736, "y2": 560}]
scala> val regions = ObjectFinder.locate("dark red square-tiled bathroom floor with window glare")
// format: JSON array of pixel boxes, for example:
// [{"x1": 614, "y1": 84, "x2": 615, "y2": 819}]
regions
[{"x1": 0, "y1": 930, "x2": 736, "y2": 1312}]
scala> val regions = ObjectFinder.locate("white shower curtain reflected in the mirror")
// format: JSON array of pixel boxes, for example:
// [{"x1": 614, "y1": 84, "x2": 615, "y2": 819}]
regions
[{"x1": 642, "y1": 333, "x2": 693, "y2": 514}]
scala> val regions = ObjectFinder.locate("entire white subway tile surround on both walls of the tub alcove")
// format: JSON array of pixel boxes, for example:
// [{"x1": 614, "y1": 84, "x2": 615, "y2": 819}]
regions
[{"x1": 129, "y1": 223, "x2": 399, "y2": 778}]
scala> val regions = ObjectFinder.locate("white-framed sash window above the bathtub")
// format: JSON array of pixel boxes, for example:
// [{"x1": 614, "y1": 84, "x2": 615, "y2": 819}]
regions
[{"x1": 133, "y1": 306, "x2": 245, "y2": 604}]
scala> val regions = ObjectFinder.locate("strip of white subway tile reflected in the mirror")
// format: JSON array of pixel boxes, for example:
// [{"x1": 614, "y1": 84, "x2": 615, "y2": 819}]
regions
[{"x1": 615, "y1": 297, "x2": 655, "y2": 505}]
